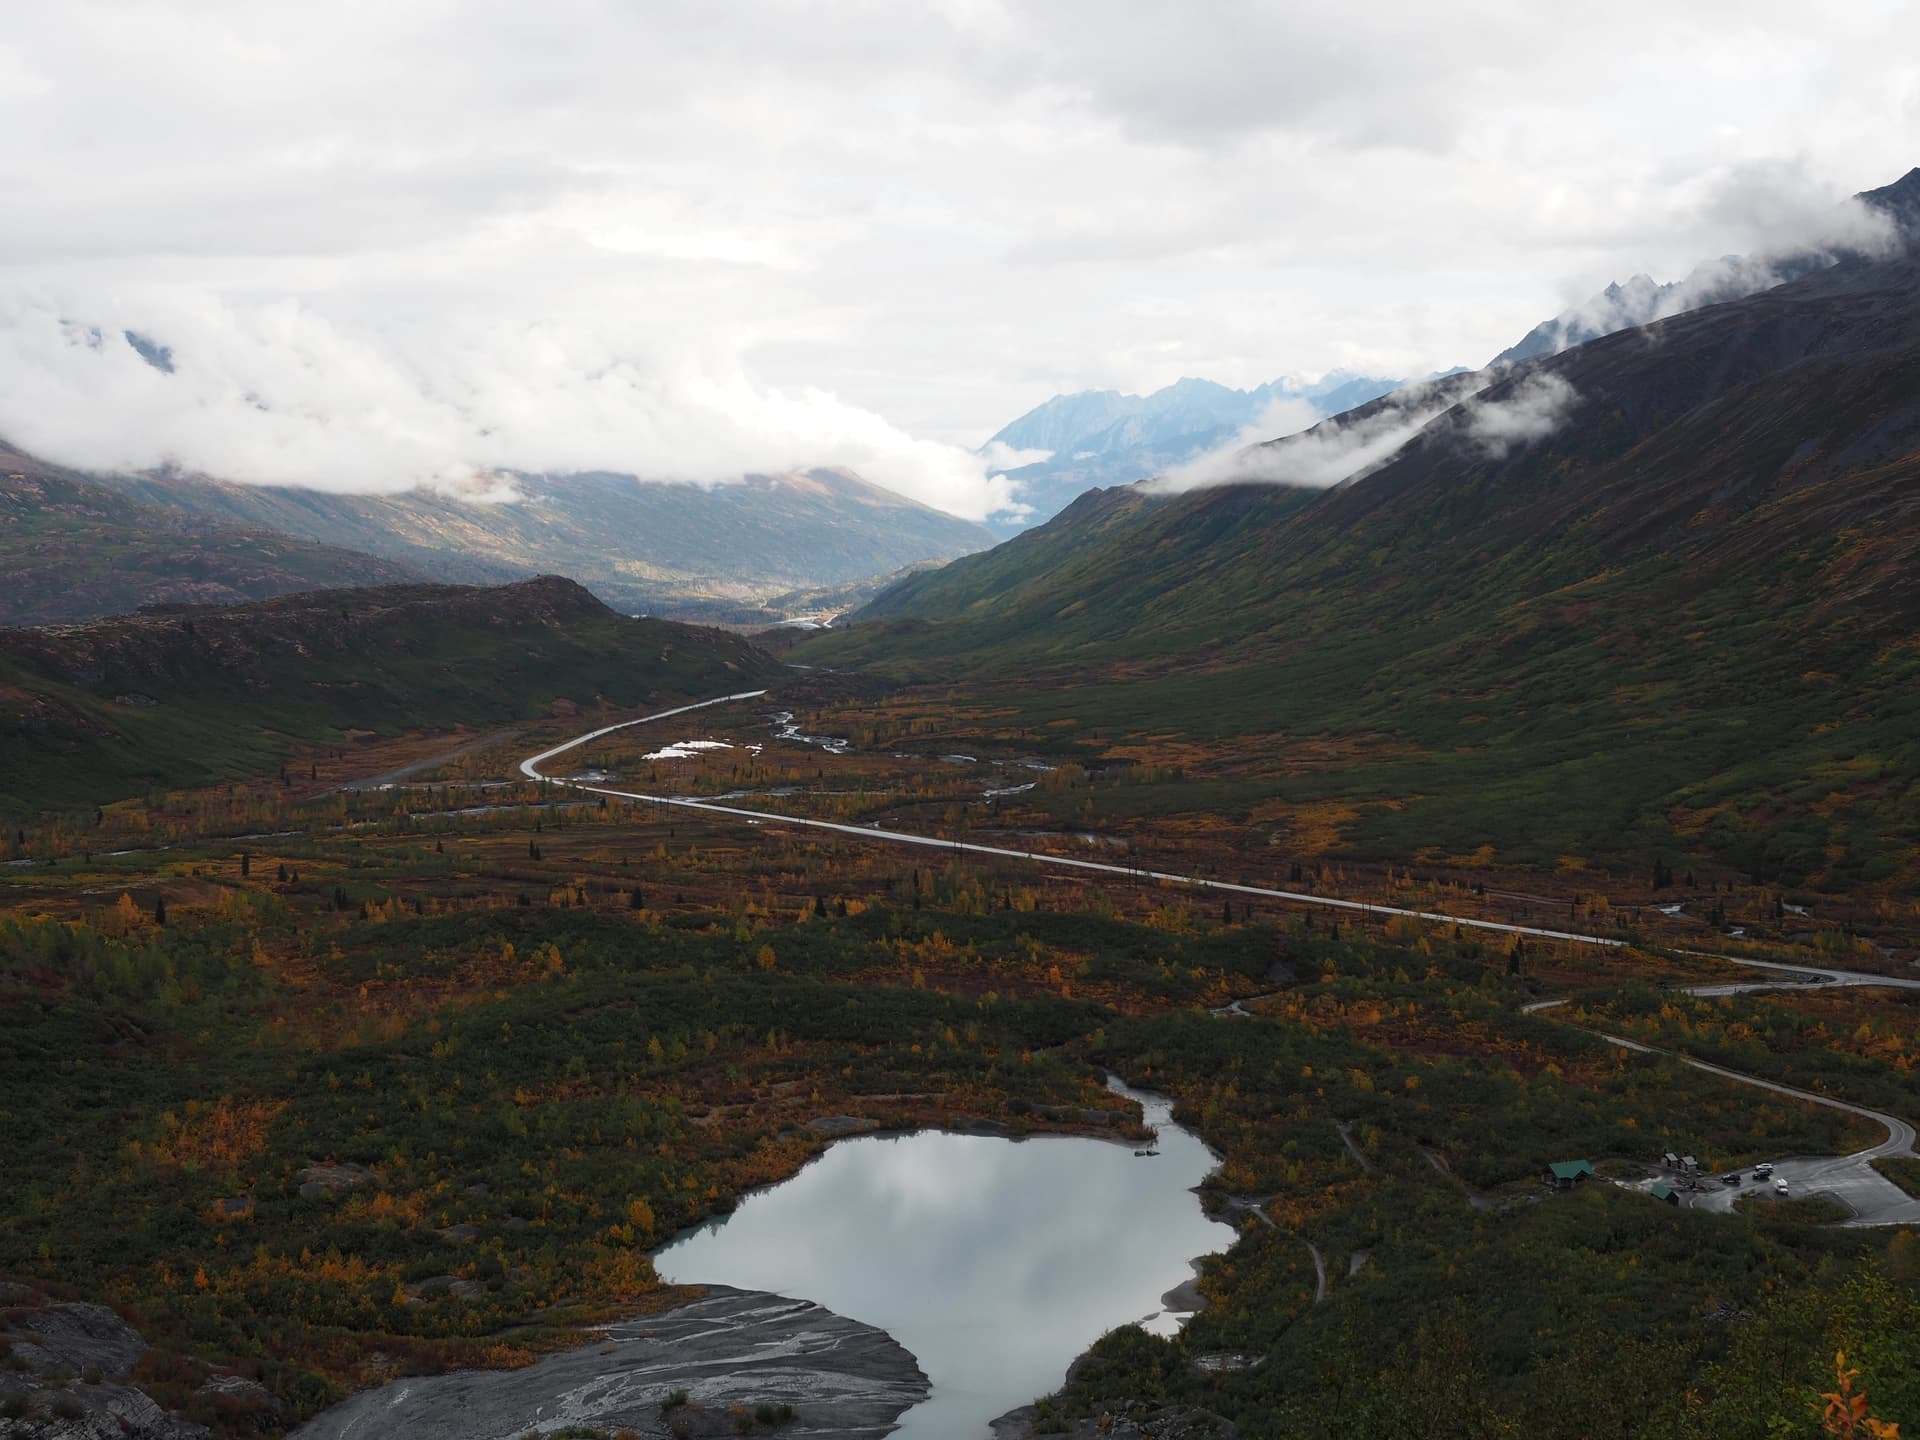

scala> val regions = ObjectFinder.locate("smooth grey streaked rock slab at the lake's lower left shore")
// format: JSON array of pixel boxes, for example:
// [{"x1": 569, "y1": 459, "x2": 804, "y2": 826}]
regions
[{"x1": 294, "y1": 1284, "x2": 927, "y2": 1440}]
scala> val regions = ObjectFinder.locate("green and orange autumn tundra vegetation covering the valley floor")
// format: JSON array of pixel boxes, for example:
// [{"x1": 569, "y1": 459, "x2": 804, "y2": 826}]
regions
[{"x1": 0, "y1": 707, "x2": 1920, "y2": 1436}]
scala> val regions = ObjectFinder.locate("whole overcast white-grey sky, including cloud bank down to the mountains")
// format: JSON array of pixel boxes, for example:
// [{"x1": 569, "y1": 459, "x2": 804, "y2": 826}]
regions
[{"x1": 0, "y1": 0, "x2": 1920, "y2": 516}]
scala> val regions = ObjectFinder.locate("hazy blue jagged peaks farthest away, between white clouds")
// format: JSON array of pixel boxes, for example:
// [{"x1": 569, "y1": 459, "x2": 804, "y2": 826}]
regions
[{"x1": 987, "y1": 371, "x2": 1402, "y2": 534}]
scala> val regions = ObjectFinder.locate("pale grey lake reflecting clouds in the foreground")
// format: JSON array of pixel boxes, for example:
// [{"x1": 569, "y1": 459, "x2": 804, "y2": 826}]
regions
[{"x1": 655, "y1": 1083, "x2": 1235, "y2": 1440}]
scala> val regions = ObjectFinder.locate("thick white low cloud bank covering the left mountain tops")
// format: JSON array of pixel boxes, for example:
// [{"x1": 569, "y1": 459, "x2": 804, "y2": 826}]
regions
[{"x1": 0, "y1": 294, "x2": 1020, "y2": 518}]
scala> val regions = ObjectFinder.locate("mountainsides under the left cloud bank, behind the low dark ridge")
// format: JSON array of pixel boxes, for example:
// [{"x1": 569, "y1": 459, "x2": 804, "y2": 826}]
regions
[{"x1": 0, "y1": 447, "x2": 995, "y2": 624}]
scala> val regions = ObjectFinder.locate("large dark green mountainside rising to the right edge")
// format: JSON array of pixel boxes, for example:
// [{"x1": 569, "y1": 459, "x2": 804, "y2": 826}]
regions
[{"x1": 803, "y1": 245, "x2": 1920, "y2": 885}]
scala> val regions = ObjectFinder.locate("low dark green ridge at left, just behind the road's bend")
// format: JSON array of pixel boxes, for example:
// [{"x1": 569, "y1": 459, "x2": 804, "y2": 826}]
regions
[{"x1": 0, "y1": 576, "x2": 774, "y2": 812}]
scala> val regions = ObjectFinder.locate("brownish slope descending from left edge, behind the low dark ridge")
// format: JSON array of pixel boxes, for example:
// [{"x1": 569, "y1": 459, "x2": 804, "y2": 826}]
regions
[{"x1": 0, "y1": 447, "x2": 420, "y2": 626}]
